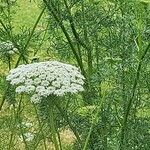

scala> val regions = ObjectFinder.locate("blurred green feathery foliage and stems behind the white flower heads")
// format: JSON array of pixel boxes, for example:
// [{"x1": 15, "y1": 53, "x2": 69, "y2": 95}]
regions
[{"x1": 0, "y1": 0, "x2": 150, "y2": 150}]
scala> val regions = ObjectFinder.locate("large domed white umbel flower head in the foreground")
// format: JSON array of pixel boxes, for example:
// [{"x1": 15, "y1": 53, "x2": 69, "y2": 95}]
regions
[{"x1": 6, "y1": 61, "x2": 84, "y2": 103}]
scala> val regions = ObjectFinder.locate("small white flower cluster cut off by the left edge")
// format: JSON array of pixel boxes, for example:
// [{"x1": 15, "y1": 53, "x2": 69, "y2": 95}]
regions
[{"x1": 0, "y1": 41, "x2": 18, "y2": 55}]
